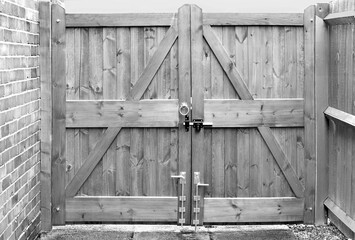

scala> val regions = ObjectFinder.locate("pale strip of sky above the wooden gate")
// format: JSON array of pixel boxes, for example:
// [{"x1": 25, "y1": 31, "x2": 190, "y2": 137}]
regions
[{"x1": 65, "y1": 0, "x2": 329, "y2": 13}]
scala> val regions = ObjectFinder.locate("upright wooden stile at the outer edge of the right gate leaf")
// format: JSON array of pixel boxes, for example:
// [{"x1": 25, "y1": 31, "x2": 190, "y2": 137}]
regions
[{"x1": 304, "y1": 6, "x2": 321, "y2": 223}]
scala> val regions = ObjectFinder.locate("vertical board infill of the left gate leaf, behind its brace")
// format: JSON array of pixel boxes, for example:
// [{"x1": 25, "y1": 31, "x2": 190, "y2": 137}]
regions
[{"x1": 66, "y1": 27, "x2": 178, "y2": 196}]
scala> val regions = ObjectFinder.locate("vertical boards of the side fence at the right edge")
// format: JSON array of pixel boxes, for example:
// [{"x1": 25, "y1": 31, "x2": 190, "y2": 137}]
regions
[{"x1": 326, "y1": 0, "x2": 355, "y2": 229}]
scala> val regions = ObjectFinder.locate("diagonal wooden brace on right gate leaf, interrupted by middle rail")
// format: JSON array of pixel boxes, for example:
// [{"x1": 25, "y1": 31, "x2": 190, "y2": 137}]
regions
[{"x1": 203, "y1": 26, "x2": 304, "y2": 197}]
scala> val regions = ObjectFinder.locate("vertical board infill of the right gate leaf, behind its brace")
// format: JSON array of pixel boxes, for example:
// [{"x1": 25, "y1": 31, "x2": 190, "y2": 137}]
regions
[{"x1": 203, "y1": 26, "x2": 305, "y2": 200}]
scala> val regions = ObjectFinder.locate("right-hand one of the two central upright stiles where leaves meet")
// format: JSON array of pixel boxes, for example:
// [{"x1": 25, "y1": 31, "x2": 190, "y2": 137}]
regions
[{"x1": 191, "y1": 5, "x2": 206, "y2": 225}]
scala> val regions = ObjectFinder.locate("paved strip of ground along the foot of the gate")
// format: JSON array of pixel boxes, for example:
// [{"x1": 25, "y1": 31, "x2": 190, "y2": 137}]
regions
[{"x1": 40, "y1": 225, "x2": 296, "y2": 240}]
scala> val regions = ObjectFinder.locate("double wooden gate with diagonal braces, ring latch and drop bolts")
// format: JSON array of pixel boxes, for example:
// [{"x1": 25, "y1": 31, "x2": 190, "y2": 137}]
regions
[{"x1": 46, "y1": 5, "x2": 307, "y2": 224}]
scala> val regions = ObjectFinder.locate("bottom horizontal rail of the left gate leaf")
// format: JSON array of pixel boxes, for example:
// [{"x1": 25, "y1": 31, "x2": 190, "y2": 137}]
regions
[{"x1": 65, "y1": 197, "x2": 177, "y2": 222}]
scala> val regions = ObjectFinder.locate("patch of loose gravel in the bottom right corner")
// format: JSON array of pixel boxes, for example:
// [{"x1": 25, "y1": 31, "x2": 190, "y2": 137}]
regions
[{"x1": 288, "y1": 224, "x2": 348, "y2": 240}]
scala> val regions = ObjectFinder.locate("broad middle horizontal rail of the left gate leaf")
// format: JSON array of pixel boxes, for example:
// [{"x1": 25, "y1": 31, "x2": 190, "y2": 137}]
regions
[{"x1": 66, "y1": 100, "x2": 179, "y2": 128}]
